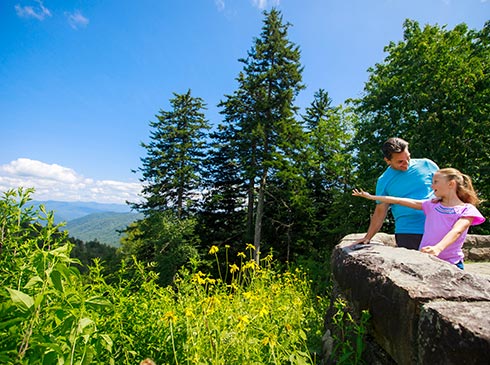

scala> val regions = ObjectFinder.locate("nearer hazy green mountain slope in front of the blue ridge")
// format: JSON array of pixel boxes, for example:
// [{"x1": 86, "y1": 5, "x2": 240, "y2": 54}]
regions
[{"x1": 62, "y1": 212, "x2": 143, "y2": 247}]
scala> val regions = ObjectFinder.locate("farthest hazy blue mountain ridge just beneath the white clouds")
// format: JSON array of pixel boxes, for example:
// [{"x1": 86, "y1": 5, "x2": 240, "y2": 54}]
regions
[{"x1": 26, "y1": 200, "x2": 131, "y2": 223}]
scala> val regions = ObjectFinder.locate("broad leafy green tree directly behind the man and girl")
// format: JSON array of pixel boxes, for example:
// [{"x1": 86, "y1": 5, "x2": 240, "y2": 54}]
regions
[{"x1": 354, "y1": 20, "x2": 490, "y2": 231}]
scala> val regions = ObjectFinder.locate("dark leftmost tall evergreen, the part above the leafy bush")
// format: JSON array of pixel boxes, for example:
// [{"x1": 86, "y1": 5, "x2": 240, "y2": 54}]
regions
[{"x1": 133, "y1": 90, "x2": 209, "y2": 218}]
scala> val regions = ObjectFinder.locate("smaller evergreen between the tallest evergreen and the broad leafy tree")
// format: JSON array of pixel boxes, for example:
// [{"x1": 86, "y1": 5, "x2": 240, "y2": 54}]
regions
[{"x1": 302, "y1": 89, "x2": 352, "y2": 248}]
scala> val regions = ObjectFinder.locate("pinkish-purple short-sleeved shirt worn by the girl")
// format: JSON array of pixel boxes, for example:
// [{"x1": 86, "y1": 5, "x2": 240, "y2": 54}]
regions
[{"x1": 419, "y1": 200, "x2": 485, "y2": 264}]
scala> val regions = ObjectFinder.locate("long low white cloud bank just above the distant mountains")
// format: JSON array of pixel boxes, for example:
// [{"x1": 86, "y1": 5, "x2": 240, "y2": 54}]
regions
[{"x1": 0, "y1": 158, "x2": 141, "y2": 204}]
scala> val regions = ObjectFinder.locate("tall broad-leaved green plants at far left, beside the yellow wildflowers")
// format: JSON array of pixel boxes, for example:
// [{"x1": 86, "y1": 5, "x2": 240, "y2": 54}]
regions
[{"x1": 0, "y1": 189, "x2": 112, "y2": 364}]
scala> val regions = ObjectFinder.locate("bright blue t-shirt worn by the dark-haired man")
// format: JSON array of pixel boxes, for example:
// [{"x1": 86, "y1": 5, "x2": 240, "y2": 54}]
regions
[{"x1": 376, "y1": 158, "x2": 439, "y2": 234}]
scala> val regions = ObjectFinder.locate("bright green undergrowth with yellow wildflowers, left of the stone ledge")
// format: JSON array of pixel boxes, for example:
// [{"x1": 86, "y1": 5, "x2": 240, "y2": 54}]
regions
[{"x1": 0, "y1": 189, "x2": 334, "y2": 364}]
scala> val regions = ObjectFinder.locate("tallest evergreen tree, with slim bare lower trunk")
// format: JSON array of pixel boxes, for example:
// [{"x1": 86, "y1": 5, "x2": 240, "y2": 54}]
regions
[{"x1": 220, "y1": 9, "x2": 304, "y2": 260}]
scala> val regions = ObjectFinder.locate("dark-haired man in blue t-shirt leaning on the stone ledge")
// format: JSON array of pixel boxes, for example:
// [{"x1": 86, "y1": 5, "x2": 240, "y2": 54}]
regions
[{"x1": 356, "y1": 138, "x2": 439, "y2": 250}]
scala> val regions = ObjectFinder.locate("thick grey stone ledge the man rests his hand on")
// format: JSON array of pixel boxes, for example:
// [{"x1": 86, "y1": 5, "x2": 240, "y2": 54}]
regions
[{"x1": 332, "y1": 234, "x2": 490, "y2": 364}]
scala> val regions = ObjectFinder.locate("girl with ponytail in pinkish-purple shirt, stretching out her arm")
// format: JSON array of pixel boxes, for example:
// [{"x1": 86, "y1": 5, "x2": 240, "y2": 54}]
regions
[{"x1": 352, "y1": 168, "x2": 485, "y2": 269}]
